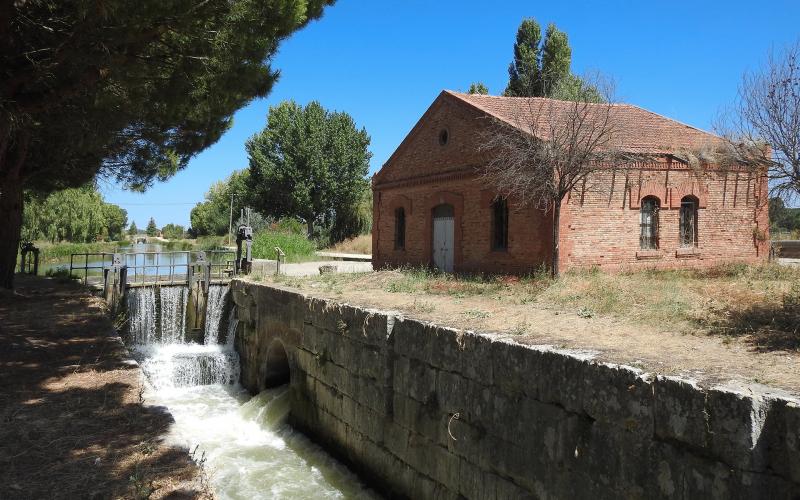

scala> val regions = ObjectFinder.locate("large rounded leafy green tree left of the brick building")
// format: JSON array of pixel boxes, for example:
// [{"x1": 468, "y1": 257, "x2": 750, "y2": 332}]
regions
[{"x1": 246, "y1": 101, "x2": 371, "y2": 242}]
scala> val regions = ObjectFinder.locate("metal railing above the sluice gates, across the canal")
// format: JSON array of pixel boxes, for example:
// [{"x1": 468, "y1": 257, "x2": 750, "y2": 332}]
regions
[{"x1": 69, "y1": 250, "x2": 236, "y2": 285}]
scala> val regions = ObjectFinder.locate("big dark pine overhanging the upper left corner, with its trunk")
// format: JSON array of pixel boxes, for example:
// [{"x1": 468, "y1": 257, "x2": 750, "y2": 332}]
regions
[{"x1": 0, "y1": 0, "x2": 332, "y2": 288}]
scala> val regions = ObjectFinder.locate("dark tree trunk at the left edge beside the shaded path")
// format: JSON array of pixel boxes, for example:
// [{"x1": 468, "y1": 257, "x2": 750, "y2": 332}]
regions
[{"x1": 0, "y1": 176, "x2": 23, "y2": 289}]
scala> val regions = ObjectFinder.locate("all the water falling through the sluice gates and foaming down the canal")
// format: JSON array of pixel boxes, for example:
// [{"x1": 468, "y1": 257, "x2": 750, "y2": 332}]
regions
[{"x1": 128, "y1": 286, "x2": 379, "y2": 499}]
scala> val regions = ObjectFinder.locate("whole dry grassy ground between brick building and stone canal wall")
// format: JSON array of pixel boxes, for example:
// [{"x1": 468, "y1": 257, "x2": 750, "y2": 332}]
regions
[{"x1": 253, "y1": 264, "x2": 800, "y2": 394}]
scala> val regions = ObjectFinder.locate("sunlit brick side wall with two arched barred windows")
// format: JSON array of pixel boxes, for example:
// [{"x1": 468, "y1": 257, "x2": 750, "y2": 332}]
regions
[{"x1": 559, "y1": 164, "x2": 769, "y2": 269}]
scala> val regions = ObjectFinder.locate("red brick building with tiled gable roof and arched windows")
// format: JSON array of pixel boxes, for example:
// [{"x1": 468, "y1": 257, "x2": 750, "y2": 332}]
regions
[{"x1": 372, "y1": 91, "x2": 769, "y2": 273}]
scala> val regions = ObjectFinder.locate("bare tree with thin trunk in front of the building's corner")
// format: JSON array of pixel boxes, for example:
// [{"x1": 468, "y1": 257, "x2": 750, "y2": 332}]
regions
[{"x1": 480, "y1": 77, "x2": 623, "y2": 276}]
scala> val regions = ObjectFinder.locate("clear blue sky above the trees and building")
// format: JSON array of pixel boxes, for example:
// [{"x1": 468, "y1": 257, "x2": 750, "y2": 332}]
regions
[{"x1": 101, "y1": 0, "x2": 800, "y2": 227}]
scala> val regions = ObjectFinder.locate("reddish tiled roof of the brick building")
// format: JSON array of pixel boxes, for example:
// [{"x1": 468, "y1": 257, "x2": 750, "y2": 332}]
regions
[{"x1": 445, "y1": 90, "x2": 722, "y2": 154}]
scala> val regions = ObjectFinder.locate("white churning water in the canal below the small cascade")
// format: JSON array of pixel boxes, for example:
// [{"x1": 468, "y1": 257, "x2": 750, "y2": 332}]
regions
[{"x1": 148, "y1": 385, "x2": 379, "y2": 500}]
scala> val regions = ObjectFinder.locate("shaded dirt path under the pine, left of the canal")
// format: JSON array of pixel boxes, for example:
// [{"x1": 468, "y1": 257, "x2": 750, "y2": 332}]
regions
[{"x1": 0, "y1": 277, "x2": 210, "y2": 499}]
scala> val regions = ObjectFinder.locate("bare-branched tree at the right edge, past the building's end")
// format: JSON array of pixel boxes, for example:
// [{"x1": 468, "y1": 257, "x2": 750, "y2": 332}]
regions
[{"x1": 715, "y1": 41, "x2": 800, "y2": 199}]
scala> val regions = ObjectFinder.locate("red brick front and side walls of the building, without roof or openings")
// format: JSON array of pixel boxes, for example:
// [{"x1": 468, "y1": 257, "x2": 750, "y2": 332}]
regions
[{"x1": 372, "y1": 93, "x2": 769, "y2": 273}]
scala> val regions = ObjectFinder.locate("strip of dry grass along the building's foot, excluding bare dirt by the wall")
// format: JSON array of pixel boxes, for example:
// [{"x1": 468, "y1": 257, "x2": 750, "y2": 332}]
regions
[{"x1": 255, "y1": 264, "x2": 800, "y2": 349}]
